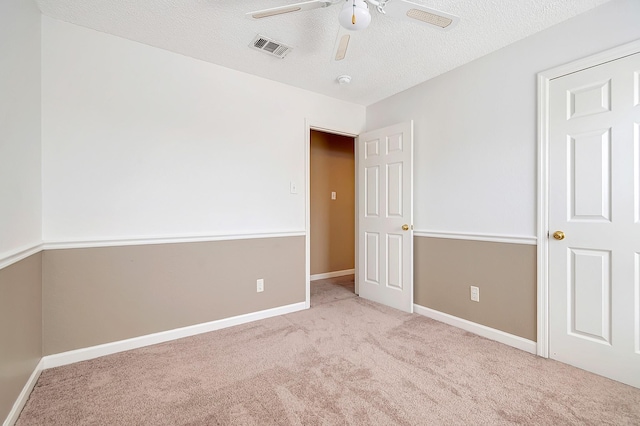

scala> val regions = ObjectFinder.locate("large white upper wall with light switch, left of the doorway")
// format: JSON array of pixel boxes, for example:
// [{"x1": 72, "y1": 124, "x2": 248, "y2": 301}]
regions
[{"x1": 42, "y1": 17, "x2": 365, "y2": 242}]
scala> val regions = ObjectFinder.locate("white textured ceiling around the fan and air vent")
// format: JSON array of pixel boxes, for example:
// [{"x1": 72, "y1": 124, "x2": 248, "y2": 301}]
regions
[{"x1": 36, "y1": 0, "x2": 610, "y2": 105}]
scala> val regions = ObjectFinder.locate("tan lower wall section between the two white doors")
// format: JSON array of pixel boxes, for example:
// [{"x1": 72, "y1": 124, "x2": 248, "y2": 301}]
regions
[{"x1": 414, "y1": 237, "x2": 537, "y2": 341}]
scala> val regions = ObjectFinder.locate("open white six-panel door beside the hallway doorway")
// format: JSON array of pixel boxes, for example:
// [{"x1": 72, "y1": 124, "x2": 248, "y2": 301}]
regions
[{"x1": 356, "y1": 121, "x2": 413, "y2": 312}]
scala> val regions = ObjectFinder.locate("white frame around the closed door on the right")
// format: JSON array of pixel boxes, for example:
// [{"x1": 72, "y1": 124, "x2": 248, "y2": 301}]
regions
[{"x1": 536, "y1": 40, "x2": 640, "y2": 358}]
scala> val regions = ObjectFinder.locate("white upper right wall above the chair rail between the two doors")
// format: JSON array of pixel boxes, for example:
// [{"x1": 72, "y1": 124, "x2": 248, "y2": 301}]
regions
[{"x1": 367, "y1": 0, "x2": 640, "y2": 237}]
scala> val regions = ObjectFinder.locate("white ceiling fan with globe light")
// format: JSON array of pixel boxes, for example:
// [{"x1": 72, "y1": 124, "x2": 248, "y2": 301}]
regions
[{"x1": 247, "y1": 0, "x2": 459, "y2": 61}]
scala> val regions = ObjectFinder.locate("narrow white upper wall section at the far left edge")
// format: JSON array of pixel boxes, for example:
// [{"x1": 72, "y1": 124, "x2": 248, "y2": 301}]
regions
[{"x1": 0, "y1": 0, "x2": 41, "y2": 261}]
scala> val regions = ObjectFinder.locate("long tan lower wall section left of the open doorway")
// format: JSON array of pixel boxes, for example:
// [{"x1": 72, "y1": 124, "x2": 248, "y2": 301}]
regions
[{"x1": 42, "y1": 237, "x2": 305, "y2": 355}]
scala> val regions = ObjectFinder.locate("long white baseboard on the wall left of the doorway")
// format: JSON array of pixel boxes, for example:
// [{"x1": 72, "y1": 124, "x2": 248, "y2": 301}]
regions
[{"x1": 42, "y1": 302, "x2": 305, "y2": 369}]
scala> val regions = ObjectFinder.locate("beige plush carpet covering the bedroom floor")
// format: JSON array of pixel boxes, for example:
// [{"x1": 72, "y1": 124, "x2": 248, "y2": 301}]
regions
[{"x1": 17, "y1": 277, "x2": 640, "y2": 426}]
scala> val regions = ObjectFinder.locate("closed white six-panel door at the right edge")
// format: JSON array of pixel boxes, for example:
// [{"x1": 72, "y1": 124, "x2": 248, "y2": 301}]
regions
[{"x1": 549, "y1": 54, "x2": 640, "y2": 387}]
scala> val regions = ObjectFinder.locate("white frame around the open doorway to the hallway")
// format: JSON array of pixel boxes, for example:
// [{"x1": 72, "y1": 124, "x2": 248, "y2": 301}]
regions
[{"x1": 304, "y1": 119, "x2": 358, "y2": 309}]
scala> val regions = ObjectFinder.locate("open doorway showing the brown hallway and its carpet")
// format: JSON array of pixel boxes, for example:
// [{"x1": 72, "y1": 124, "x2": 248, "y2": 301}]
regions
[{"x1": 309, "y1": 129, "x2": 356, "y2": 306}]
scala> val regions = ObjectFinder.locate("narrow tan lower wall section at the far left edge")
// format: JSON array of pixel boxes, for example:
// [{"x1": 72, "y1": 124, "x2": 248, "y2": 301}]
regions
[{"x1": 0, "y1": 253, "x2": 42, "y2": 421}]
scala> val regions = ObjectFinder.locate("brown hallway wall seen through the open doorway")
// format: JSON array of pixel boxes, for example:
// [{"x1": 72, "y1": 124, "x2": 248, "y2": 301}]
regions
[{"x1": 310, "y1": 130, "x2": 355, "y2": 275}]
